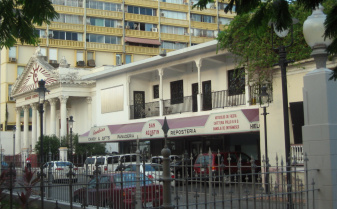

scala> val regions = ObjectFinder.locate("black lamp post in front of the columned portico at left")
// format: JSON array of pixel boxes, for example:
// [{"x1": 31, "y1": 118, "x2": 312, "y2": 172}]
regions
[{"x1": 35, "y1": 79, "x2": 49, "y2": 209}]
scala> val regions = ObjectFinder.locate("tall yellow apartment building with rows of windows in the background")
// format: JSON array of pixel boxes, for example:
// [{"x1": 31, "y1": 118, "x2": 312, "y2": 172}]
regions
[{"x1": 0, "y1": 0, "x2": 235, "y2": 130}]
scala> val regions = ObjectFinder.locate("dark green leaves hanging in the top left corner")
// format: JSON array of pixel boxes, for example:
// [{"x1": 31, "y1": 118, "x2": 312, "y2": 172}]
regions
[{"x1": 0, "y1": 0, "x2": 58, "y2": 49}]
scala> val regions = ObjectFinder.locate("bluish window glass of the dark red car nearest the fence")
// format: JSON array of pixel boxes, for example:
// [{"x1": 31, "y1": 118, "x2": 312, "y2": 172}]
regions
[{"x1": 114, "y1": 173, "x2": 152, "y2": 187}]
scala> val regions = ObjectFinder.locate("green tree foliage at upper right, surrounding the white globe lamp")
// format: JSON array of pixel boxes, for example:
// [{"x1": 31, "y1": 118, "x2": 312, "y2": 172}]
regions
[{"x1": 194, "y1": 0, "x2": 337, "y2": 81}]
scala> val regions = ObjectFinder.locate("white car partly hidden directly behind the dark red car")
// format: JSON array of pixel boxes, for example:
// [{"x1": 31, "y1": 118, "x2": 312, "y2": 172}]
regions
[{"x1": 124, "y1": 163, "x2": 175, "y2": 186}]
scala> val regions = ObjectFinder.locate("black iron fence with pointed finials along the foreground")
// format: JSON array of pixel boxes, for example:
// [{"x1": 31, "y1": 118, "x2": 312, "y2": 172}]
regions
[{"x1": 0, "y1": 152, "x2": 316, "y2": 209}]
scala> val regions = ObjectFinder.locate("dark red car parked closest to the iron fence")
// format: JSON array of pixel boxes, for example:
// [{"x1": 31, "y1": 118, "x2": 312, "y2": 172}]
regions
[{"x1": 74, "y1": 172, "x2": 163, "y2": 209}]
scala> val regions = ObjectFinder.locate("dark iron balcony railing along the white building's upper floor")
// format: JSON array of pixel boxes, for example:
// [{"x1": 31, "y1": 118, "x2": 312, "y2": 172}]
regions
[{"x1": 130, "y1": 90, "x2": 246, "y2": 119}]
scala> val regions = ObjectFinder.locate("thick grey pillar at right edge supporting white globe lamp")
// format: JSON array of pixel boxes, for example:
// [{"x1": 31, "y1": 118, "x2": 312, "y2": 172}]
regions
[{"x1": 302, "y1": 68, "x2": 337, "y2": 209}]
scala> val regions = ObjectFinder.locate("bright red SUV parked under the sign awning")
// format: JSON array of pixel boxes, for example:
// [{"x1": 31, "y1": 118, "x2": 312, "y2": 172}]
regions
[{"x1": 194, "y1": 152, "x2": 261, "y2": 180}]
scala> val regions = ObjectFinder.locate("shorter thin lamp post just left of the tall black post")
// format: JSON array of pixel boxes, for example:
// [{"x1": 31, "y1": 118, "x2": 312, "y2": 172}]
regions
[{"x1": 259, "y1": 86, "x2": 270, "y2": 194}]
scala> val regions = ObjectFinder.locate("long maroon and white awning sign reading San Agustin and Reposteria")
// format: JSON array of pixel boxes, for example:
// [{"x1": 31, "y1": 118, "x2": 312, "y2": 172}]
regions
[{"x1": 79, "y1": 109, "x2": 260, "y2": 143}]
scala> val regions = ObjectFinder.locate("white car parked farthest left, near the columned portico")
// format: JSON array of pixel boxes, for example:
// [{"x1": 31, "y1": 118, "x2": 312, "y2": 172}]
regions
[{"x1": 37, "y1": 161, "x2": 78, "y2": 182}]
